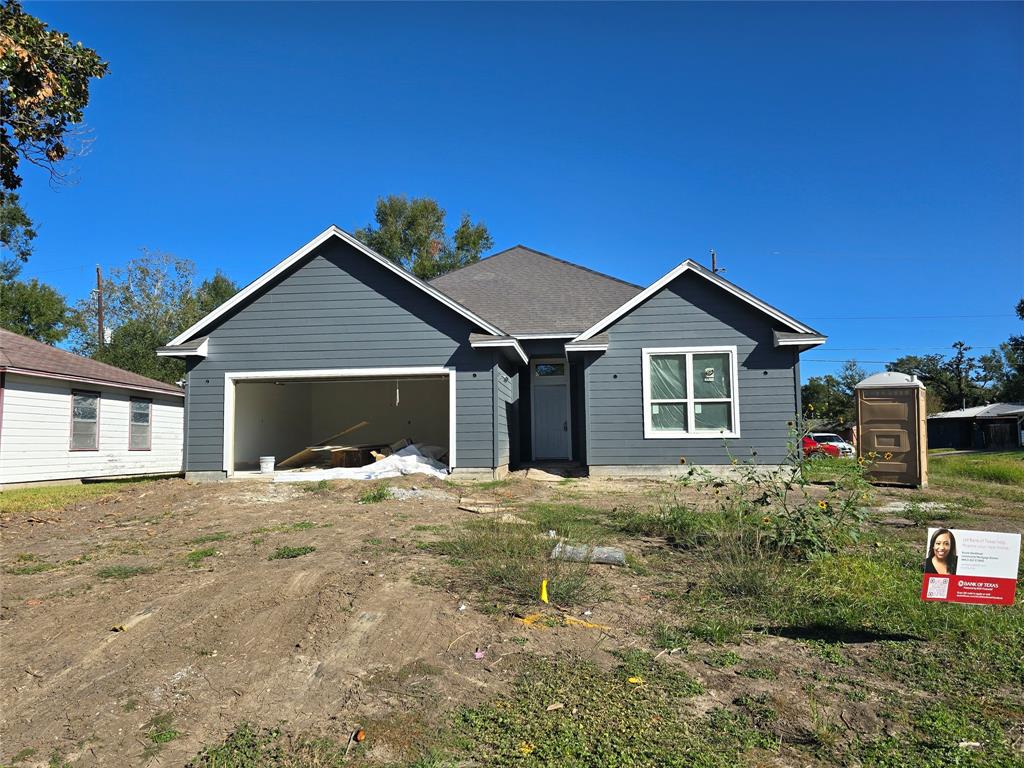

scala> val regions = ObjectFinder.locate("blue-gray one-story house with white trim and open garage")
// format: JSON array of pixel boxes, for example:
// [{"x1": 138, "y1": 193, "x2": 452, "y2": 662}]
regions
[{"x1": 160, "y1": 227, "x2": 825, "y2": 478}]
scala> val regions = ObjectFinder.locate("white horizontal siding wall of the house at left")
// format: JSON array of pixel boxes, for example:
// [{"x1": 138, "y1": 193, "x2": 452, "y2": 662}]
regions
[{"x1": 0, "y1": 373, "x2": 183, "y2": 484}]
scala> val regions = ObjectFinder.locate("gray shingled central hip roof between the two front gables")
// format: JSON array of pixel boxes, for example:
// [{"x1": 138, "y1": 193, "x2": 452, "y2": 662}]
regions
[{"x1": 430, "y1": 245, "x2": 641, "y2": 331}]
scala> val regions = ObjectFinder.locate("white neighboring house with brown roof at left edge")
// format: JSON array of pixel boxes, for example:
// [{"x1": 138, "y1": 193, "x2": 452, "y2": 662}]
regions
[{"x1": 0, "y1": 329, "x2": 184, "y2": 489}]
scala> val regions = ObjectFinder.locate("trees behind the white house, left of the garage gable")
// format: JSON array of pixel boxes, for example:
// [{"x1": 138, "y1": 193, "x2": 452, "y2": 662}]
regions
[{"x1": 74, "y1": 249, "x2": 238, "y2": 383}]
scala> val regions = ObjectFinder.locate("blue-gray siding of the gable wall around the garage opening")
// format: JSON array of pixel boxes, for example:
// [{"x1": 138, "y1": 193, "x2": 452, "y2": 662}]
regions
[{"x1": 186, "y1": 241, "x2": 495, "y2": 471}]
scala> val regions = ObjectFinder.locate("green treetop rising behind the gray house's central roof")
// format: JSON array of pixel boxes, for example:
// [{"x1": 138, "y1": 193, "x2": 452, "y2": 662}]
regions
[{"x1": 355, "y1": 195, "x2": 494, "y2": 280}]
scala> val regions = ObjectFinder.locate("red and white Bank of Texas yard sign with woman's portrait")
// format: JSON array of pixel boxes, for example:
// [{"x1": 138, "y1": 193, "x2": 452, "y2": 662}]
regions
[{"x1": 921, "y1": 528, "x2": 1021, "y2": 605}]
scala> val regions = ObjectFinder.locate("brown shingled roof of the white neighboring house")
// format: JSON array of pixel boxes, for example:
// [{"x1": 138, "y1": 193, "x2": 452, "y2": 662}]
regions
[{"x1": 0, "y1": 329, "x2": 184, "y2": 397}]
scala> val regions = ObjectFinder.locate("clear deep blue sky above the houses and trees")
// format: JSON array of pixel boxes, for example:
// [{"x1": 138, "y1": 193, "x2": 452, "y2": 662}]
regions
[{"x1": 16, "y1": 2, "x2": 1024, "y2": 379}]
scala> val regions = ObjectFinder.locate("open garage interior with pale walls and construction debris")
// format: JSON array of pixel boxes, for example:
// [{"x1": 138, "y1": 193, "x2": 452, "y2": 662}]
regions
[{"x1": 232, "y1": 376, "x2": 450, "y2": 472}]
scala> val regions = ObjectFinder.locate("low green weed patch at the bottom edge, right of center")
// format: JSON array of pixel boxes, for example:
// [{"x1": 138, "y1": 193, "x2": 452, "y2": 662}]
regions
[{"x1": 440, "y1": 651, "x2": 775, "y2": 768}]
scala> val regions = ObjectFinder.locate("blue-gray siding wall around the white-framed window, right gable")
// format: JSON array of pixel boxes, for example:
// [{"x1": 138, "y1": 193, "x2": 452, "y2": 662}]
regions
[{"x1": 585, "y1": 273, "x2": 799, "y2": 466}]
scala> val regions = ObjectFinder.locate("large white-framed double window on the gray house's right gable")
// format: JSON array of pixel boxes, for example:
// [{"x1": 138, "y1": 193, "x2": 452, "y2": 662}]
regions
[{"x1": 643, "y1": 347, "x2": 739, "y2": 437}]
